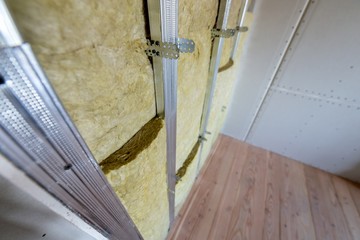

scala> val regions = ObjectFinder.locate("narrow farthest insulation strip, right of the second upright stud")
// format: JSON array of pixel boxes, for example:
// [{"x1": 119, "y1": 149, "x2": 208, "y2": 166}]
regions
[{"x1": 201, "y1": 12, "x2": 253, "y2": 166}]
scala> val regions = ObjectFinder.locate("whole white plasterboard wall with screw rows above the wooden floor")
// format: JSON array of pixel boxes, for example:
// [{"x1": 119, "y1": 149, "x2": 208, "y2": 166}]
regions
[{"x1": 223, "y1": 0, "x2": 360, "y2": 182}]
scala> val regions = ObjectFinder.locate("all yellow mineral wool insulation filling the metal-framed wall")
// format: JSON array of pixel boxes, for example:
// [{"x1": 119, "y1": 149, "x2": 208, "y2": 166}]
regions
[{"x1": 7, "y1": 0, "x2": 250, "y2": 240}]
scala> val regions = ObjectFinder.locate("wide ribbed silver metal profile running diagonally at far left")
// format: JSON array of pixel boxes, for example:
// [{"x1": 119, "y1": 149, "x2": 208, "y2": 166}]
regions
[{"x1": 0, "y1": 0, "x2": 142, "y2": 239}]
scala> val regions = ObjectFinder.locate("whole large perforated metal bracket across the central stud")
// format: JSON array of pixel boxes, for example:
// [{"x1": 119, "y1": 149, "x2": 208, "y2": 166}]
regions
[{"x1": 145, "y1": 38, "x2": 195, "y2": 59}]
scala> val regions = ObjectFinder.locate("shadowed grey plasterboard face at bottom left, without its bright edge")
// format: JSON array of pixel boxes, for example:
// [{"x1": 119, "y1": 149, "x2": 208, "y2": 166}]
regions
[{"x1": 0, "y1": 175, "x2": 95, "y2": 240}]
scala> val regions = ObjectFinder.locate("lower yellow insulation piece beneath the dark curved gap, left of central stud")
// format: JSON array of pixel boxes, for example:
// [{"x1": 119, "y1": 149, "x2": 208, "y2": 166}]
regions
[{"x1": 106, "y1": 122, "x2": 169, "y2": 240}]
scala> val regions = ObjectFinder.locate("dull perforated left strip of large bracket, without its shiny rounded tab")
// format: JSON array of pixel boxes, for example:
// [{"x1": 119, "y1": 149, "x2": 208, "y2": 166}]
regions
[{"x1": 145, "y1": 40, "x2": 179, "y2": 59}]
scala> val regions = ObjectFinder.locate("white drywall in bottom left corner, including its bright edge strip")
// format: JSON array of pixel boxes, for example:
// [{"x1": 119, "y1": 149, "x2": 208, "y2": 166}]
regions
[{"x1": 0, "y1": 155, "x2": 106, "y2": 240}]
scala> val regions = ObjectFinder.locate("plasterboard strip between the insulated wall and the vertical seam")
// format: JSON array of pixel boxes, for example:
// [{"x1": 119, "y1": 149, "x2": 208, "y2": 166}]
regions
[{"x1": 223, "y1": 0, "x2": 305, "y2": 140}]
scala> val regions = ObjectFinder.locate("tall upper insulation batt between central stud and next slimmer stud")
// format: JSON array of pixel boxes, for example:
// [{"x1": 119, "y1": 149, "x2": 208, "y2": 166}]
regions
[{"x1": 176, "y1": 0, "x2": 218, "y2": 169}]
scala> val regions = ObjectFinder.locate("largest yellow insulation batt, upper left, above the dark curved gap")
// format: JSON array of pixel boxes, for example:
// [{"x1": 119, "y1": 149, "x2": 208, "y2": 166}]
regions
[{"x1": 7, "y1": 0, "x2": 155, "y2": 162}]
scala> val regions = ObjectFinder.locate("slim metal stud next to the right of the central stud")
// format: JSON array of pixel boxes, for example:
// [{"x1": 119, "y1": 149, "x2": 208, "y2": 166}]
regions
[{"x1": 197, "y1": 0, "x2": 231, "y2": 174}]
